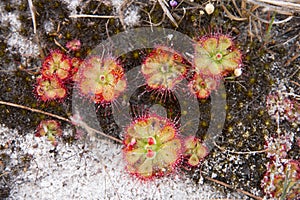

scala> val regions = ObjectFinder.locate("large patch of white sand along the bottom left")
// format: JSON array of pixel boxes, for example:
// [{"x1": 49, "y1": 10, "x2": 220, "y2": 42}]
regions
[{"x1": 0, "y1": 125, "x2": 241, "y2": 199}]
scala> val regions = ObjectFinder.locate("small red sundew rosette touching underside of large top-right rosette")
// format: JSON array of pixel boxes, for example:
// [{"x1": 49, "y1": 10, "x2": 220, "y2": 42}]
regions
[{"x1": 189, "y1": 73, "x2": 219, "y2": 99}]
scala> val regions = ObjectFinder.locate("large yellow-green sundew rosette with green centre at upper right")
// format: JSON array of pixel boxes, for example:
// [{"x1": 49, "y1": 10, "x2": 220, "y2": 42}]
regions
[{"x1": 193, "y1": 34, "x2": 242, "y2": 77}]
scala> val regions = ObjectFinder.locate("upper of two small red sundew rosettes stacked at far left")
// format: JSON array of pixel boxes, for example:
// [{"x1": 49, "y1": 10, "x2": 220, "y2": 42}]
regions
[{"x1": 41, "y1": 50, "x2": 72, "y2": 80}]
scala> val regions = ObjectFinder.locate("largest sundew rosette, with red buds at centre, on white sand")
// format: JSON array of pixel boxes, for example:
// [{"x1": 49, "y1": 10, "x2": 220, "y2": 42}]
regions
[{"x1": 123, "y1": 115, "x2": 182, "y2": 180}]
